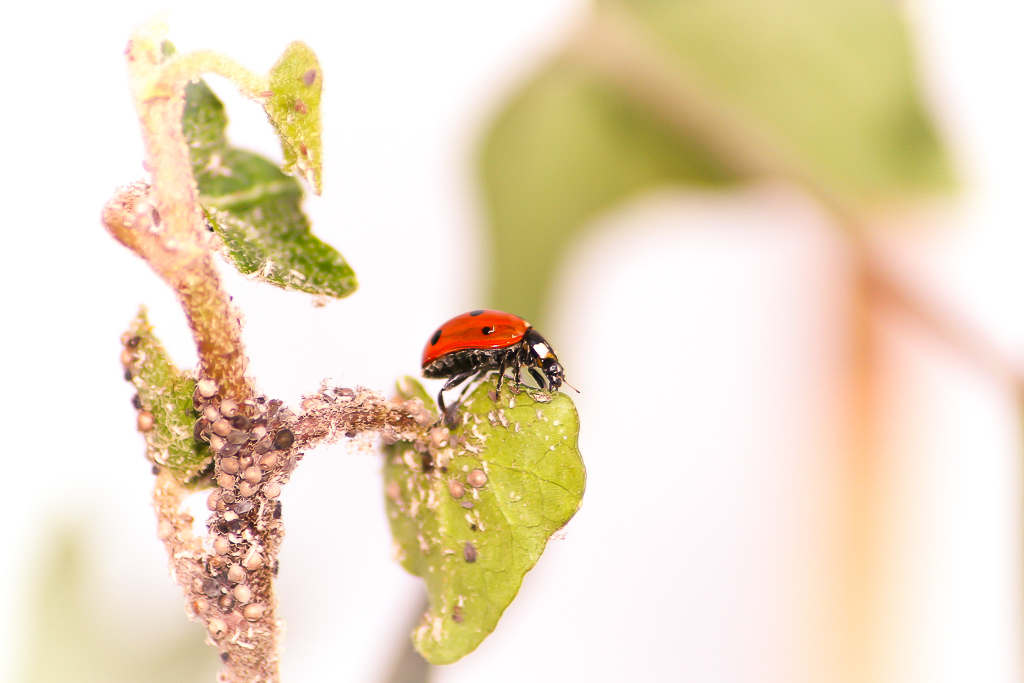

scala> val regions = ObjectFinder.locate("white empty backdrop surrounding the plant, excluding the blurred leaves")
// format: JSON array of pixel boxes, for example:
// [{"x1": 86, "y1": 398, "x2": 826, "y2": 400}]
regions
[{"x1": 0, "y1": 0, "x2": 1024, "y2": 683}]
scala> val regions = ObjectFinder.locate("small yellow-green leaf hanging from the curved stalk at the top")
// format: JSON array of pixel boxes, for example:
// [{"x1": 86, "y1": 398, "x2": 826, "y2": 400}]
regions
[{"x1": 263, "y1": 42, "x2": 324, "y2": 195}]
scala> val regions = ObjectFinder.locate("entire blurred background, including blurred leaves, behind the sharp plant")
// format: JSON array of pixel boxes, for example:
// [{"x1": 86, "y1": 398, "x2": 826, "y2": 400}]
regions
[{"x1": 0, "y1": 0, "x2": 1024, "y2": 683}]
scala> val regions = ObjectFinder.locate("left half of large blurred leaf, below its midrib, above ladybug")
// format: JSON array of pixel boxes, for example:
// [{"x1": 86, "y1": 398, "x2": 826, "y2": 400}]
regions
[{"x1": 480, "y1": 58, "x2": 736, "y2": 327}]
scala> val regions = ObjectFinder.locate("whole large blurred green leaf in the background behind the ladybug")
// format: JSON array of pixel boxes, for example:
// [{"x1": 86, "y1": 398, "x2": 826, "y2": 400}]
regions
[{"x1": 480, "y1": 0, "x2": 951, "y2": 325}]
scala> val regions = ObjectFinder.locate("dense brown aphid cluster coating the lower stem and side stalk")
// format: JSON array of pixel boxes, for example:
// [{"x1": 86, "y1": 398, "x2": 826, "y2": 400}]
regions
[{"x1": 122, "y1": 333, "x2": 434, "y2": 681}]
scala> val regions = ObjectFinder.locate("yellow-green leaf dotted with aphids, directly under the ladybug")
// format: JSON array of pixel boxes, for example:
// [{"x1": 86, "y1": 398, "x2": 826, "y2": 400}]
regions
[{"x1": 384, "y1": 380, "x2": 586, "y2": 665}]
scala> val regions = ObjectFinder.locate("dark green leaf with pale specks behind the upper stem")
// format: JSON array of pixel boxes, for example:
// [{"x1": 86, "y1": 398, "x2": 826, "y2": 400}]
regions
[{"x1": 182, "y1": 77, "x2": 356, "y2": 298}]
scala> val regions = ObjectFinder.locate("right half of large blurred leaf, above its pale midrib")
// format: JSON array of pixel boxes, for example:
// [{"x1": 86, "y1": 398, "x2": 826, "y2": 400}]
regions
[{"x1": 598, "y1": 0, "x2": 952, "y2": 202}]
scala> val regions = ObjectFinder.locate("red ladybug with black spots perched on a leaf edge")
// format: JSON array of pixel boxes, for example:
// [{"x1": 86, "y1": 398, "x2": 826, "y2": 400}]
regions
[{"x1": 422, "y1": 309, "x2": 565, "y2": 415}]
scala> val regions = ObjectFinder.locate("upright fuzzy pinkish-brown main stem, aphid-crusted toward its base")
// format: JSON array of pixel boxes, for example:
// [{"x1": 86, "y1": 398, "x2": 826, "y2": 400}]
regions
[{"x1": 103, "y1": 20, "x2": 280, "y2": 683}]
